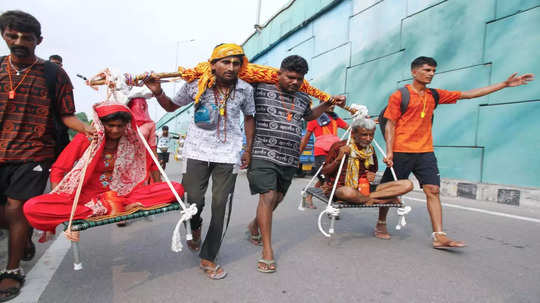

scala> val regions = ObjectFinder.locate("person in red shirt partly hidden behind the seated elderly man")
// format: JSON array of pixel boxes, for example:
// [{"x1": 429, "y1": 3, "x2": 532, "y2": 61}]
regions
[{"x1": 300, "y1": 105, "x2": 349, "y2": 209}]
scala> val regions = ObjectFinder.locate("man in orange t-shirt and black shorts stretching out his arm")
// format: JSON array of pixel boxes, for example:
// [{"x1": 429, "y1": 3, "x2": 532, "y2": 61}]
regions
[{"x1": 377, "y1": 57, "x2": 534, "y2": 248}]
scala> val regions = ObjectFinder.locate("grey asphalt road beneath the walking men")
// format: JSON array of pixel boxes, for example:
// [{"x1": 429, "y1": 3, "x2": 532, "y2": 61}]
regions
[{"x1": 2, "y1": 162, "x2": 540, "y2": 303}]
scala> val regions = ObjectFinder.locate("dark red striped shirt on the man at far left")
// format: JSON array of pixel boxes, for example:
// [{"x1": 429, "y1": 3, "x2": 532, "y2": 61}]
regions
[{"x1": 0, "y1": 57, "x2": 75, "y2": 164}]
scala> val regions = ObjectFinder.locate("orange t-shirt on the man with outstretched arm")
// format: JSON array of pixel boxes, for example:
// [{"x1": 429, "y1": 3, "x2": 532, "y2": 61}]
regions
[{"x1": 384, "y1": 84, "x2": 461, "y2": 153}]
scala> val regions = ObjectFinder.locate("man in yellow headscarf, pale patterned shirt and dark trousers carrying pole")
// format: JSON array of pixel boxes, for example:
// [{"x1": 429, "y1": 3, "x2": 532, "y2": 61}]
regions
[{"x1": 142, "y1": 44, "x2": 255, "y2": 279}]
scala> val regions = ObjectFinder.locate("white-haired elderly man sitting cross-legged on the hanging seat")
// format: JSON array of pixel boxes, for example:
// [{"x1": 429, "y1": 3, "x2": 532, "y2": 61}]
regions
[{"x1": 322, "y1": 118, "x2": 413, "y2": 239}]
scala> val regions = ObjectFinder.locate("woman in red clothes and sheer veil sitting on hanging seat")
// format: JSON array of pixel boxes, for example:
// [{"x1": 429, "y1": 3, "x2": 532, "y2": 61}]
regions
[{"x1": 24, "y1": 103, "x2": 184, "y2": 238}]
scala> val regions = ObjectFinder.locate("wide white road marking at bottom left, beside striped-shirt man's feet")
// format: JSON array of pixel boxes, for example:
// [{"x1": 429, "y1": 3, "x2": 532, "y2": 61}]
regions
[{"x1": 10, "y1": 238, "x2": 71, "y2": 303}]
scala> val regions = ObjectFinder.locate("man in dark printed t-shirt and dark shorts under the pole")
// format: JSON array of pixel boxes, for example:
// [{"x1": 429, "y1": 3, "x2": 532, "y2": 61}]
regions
[{"x1": 247, "y1": 55, "x2": 345, "y2": 273}]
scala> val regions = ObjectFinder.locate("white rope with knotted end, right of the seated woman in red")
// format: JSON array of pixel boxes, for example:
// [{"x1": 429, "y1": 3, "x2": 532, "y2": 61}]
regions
[{"x1": 137, "y1": 127, "x2": 197, "y2": 252}]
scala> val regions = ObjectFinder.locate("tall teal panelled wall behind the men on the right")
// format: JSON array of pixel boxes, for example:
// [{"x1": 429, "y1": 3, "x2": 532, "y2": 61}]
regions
[{"x1": 244, "y1": 0, "x2": 540, "y2": 187}]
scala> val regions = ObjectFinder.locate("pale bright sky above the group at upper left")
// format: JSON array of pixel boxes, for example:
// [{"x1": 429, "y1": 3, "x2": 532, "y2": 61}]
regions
[{"x1": 0, "y1": 0, "x2": 290, "y2": 121}]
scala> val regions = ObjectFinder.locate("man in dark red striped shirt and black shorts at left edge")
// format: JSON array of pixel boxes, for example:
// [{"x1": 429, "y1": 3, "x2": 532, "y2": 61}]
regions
[{"x1": 0, "y1": 11, "x2": 95, "y2": 302}]
